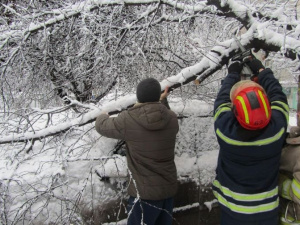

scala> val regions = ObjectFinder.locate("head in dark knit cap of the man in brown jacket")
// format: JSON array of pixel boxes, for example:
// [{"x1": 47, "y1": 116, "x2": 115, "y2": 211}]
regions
[{"x1": 136, "y1": 78, "x2": 161, "y2": 103}]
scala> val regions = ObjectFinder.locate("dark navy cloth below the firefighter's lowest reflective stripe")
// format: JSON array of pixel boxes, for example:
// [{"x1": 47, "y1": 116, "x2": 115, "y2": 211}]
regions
[{"x1": 221, "y1": 210, "x2": 278, "y2": 225}]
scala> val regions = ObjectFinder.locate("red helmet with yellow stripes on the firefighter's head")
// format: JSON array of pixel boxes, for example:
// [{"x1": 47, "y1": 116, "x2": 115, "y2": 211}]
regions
[{"x1": 230, "y1": 80, "x2": 271, "y2": 130}]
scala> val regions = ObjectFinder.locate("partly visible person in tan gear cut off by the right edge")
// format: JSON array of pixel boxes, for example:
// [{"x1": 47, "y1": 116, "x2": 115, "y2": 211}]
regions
[{"x1": 279, "y1": 126, "x2": 300, "y2": 225}]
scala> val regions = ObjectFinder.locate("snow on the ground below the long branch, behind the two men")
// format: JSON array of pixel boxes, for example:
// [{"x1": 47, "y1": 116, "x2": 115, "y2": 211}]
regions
[{"x1": 0, "y1": 97, "x2": 296, "y2": 224}]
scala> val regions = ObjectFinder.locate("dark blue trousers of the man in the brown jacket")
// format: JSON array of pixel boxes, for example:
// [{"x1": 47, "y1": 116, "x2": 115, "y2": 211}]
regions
[{"x1": 127, "y1": 196, "x2": 174, "y2": 225}]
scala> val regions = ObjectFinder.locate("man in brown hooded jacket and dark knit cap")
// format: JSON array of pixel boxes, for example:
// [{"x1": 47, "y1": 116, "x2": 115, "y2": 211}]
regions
[{"x1": 96, "y1": 78, "x2": 179, "y2": 225}]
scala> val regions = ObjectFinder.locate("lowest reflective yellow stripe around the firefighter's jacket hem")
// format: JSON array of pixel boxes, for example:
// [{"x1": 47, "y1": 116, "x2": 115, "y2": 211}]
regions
[{"x1": 213, "y1": 191, "x2": 279, "y2": 214}]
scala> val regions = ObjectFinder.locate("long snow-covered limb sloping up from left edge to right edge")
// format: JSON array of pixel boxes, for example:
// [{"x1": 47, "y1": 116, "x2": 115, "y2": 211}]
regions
[{"x1": 0, "y1": 24, "x2": 300, "y2": 144}]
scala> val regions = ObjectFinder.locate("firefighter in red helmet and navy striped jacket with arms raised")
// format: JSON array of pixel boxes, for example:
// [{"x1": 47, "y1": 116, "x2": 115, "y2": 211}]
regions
[{"x1": 213, "y1": 59, "x2": 289, "y2": 225}]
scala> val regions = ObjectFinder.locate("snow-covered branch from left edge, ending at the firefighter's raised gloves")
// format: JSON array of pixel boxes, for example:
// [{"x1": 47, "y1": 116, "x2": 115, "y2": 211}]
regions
[{"x1": 0, "y1": 37, "x2": 231, "y2": 144}]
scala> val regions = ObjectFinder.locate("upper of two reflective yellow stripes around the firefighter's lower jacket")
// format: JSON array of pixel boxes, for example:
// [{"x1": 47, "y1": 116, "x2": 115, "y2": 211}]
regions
[{"x1": 213, "y1": 180, "x2": 278, "y2": 202}]
